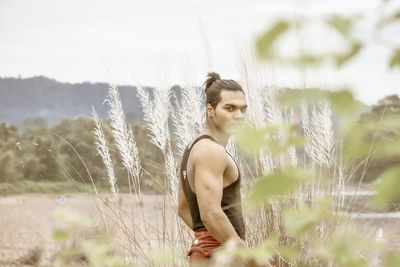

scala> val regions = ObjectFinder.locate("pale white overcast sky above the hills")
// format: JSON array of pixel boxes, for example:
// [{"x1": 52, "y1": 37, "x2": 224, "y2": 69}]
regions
[{"x1": 0, "y1": 0, "x2": 400, "y2": 104}]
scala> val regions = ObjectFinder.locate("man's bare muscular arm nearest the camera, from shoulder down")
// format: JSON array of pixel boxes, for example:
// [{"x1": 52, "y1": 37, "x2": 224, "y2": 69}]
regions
[{"x1": 194, "y1": 144, "x2": 243, "y2": 244}]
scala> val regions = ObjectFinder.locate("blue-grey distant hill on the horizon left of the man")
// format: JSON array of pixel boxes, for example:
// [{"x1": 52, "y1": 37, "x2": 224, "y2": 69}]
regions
[{"x1": 0, "y1": 76, "x2": 179, "y2": 125}]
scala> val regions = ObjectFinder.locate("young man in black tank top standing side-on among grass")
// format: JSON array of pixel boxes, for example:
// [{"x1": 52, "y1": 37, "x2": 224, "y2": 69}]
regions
[{"x1": 178, "y1": 73, "x2": 270, "y2": 266}]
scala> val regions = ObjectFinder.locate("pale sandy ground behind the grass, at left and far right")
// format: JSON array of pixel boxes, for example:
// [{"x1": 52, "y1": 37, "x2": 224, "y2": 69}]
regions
[{"x1": 0, "y1": 194, "x2": 400, "y2": 266}]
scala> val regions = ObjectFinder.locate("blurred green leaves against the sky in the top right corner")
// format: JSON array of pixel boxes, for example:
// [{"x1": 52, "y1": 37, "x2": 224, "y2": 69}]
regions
[{"x1": 255, "y1": 1, "x2": 400, "y2": 68}]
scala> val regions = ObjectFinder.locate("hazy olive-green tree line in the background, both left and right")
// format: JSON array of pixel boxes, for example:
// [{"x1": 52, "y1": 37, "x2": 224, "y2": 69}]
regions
[{"x1": 0, "y1": 95, "x2": 400, "y2": 190}]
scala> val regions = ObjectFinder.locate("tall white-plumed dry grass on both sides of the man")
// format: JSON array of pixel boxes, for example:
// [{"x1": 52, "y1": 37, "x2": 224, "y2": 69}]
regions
[{"x1": 87, "y1": 57, "x2": 382, "y2": 266}]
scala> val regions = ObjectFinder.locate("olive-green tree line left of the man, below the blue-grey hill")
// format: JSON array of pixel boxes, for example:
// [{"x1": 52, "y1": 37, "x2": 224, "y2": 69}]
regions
[{"x1": 0, "y1": 116, "x2": 164, "y2": 193}]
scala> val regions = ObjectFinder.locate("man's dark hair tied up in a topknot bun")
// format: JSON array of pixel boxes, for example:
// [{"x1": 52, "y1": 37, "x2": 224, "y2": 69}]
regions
[{"x1": 204, "y1": 72, "x2": 244, "y2": 108}]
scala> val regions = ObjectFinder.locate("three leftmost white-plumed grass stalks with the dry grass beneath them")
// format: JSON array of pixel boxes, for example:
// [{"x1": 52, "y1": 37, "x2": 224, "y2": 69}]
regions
[{"x1": 93, "y1": 82, "x2": 190, "y2": 266}]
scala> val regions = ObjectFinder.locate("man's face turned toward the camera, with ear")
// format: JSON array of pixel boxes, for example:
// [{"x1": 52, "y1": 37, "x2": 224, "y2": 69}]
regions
[{"x1": 207, "y1": 90, "x2": 247, "y2": 133}]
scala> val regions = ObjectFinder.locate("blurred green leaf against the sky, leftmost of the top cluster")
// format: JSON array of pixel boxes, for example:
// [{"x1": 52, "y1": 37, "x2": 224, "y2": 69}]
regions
[{"x1": 256, "y1": 20, "x2": 290, "y2": 59}]
